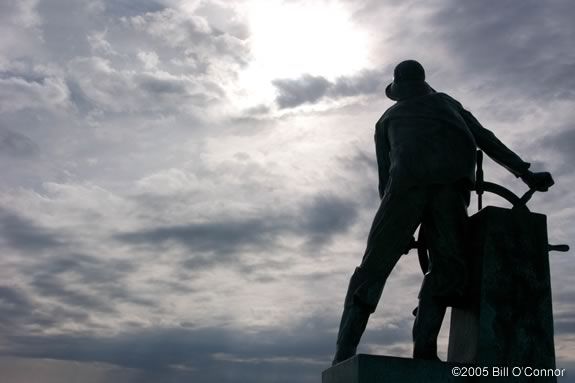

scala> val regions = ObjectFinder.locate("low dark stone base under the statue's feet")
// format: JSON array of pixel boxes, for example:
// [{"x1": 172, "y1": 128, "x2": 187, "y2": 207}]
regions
[{"x1": 321, "y1": 354, "x2": 466, "y2": 383}]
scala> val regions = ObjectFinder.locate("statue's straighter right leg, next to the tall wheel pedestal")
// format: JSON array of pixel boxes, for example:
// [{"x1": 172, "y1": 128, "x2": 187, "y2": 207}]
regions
[{"x1": 413, "y1": 185, "x2": 467, "y2": 359}]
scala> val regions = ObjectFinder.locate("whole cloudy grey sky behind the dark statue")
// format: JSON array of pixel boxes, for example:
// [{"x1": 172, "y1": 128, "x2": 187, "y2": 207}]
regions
[{"x1": 0, "y1": 0, "x2": 575, "y2": 383}]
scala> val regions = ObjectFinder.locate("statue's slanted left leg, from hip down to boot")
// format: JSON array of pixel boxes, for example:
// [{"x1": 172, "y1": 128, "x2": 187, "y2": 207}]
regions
[{"x1": 332, "y1": 188, "x2": 426, "y2": 364}]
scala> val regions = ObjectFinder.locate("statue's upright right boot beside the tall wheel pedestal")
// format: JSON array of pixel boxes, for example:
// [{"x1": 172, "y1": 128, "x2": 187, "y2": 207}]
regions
[{"x1": 413, "y1": 295, "x2": 447, "y2": 360}]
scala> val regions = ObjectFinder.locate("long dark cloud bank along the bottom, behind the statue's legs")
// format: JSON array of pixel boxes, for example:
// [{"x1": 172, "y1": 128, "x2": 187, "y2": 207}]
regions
[{"x1": 0, "y1": 308, "x2": 409, "y2": 383}]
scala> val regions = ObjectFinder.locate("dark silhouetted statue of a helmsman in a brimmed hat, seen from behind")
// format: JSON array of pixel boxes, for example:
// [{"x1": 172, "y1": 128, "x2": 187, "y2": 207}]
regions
[{"x1": 332, "y1": 60, "x2": 553, "y2": 365}]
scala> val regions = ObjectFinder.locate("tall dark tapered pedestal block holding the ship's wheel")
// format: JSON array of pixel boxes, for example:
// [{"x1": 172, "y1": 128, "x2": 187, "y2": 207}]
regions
[{"x1": 448, "y1": 206, "x2": 556, "y2": 382}]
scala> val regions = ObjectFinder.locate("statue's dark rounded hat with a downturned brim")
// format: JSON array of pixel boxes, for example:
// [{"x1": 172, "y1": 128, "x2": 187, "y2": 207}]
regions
[{"x1": 385, "y1": 60, "x2": 434, "y2": 101}]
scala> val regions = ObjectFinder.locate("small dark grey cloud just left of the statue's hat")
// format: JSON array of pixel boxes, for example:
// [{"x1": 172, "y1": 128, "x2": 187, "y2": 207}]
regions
[{"x1": 272, "y1": 70, "x2": 388, "y2": 109}]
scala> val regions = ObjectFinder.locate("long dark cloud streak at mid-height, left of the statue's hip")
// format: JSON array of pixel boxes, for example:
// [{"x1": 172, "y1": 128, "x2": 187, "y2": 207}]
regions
[{"x1": 115, "y1": 193, "x2": 357, "y2": 269}]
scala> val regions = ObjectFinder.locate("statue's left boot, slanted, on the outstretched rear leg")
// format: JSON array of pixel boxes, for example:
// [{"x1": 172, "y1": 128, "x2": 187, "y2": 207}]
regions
[{"x1": 332, "y1": 268, "x2": 373, "y2": 366}]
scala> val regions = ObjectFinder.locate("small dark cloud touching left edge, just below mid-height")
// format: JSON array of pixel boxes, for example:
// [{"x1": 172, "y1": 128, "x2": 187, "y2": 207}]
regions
[{"x1": 0, "y1": 209, "x2": 64, "y2": 252}]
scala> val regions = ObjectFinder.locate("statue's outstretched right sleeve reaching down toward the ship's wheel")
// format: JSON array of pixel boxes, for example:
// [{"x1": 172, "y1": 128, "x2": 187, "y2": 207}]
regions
[{"x1": 461, "y1": 109, "x2": 530, "y2": 177}]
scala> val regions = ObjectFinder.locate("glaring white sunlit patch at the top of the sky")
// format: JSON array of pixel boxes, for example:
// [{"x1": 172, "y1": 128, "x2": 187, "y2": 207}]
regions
[{"x1": 237, "y1": 0, "x2": 368, "y2": 107}]
